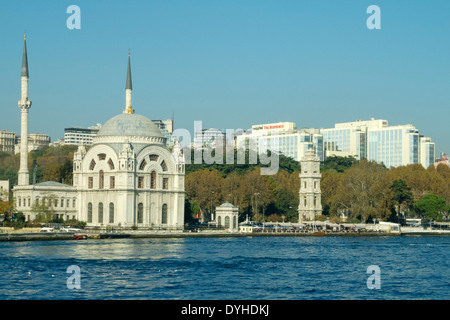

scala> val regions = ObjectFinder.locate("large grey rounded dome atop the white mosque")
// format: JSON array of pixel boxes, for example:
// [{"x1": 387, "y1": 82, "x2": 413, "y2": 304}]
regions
[{"x1": 97, "y1": 113, "x2": 164, "y2": 138}]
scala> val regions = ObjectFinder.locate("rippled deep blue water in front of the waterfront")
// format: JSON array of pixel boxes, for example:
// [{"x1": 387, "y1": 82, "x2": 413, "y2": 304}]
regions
[{"x1": 0, "y1": 236, "x2": 450, "y2": 300}]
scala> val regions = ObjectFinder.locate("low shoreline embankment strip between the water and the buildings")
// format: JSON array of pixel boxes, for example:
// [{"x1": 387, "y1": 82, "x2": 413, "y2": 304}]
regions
[{"x1": 0, "y1": 230, "x2": 450, "y2": 242}]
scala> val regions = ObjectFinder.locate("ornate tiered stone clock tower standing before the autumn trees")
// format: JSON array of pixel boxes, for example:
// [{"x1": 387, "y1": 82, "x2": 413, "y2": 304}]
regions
[{"x1": 298, "y1": 149, "x2": 322, "y2": 222}]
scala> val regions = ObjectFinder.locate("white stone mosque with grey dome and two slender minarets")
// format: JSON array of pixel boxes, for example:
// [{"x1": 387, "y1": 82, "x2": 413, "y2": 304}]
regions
[{"x1": 13, "y1": 37, "x2": 185, "y2": 229}]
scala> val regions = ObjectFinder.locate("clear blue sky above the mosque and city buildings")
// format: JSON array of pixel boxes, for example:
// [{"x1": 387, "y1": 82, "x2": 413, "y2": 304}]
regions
[{"x1": 0, "y1": 0, "x2": 450, "y2": 156}]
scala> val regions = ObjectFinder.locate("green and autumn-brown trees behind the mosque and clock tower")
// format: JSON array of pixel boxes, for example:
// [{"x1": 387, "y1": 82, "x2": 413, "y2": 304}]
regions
[{"x1": 0, "y1": 146, "x2": 450, "y2": 222}]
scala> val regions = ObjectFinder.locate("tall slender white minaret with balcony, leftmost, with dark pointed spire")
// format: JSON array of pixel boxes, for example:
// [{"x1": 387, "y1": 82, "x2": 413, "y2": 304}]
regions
[{"x1": 18, "y1": 34, "x2": 31, "y2": 186}]
